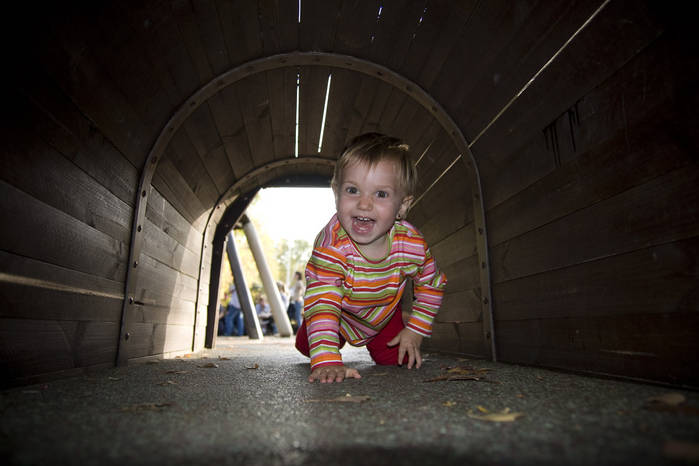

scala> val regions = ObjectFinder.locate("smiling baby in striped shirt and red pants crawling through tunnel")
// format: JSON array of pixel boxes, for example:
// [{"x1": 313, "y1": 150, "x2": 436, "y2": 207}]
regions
[{"x1": 296, "y1": 133, "x2": 446, "y2": 383}]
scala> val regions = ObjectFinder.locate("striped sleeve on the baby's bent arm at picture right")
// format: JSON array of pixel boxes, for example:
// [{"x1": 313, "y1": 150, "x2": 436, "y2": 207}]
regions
[{"x1": 406, "y1": 240, "x2": 447, "y2": 337}]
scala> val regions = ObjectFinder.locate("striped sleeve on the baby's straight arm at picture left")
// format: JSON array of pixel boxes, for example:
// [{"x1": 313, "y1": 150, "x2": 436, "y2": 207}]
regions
[{"x1": 303, "y1": 245, "x2": 346, "y2": 370}]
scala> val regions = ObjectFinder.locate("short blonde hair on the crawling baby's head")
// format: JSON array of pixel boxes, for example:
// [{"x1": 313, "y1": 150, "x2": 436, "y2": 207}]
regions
[{"x1": 330, "y1": 133, "x2": 417, "y2": 196}]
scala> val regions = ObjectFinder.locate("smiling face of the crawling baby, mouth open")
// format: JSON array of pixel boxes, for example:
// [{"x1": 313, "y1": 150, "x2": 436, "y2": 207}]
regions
[{"x1": 335, "y1": 160, "x2": 410, "y2": 259}]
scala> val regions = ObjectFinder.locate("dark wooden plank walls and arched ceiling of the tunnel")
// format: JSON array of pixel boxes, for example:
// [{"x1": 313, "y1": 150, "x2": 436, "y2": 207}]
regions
[{"x1": 0, "y1": 0, "x2": 699, "y2": 387}]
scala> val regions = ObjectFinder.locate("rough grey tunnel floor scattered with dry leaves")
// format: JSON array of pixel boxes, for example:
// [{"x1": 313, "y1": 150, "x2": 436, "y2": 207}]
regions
[{"x1": 0, "y1": 337, "x2": 699, "y2": 466}]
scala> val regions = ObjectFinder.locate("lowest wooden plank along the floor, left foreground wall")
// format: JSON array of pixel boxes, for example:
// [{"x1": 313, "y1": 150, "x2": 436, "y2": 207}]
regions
[{"x1": 0, "y1": 318, "x2": 119, "y2": 382}]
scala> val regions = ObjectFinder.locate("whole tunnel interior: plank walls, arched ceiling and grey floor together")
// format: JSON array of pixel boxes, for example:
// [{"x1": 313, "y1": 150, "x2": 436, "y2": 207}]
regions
[{"x1": 0, "y1": 0, "x2": 699, "y2": 465}]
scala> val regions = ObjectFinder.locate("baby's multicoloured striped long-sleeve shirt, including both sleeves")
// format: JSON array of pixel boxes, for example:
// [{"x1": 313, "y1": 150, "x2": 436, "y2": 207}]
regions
[{"x1": 304, "y1": 216, "x2": 446, "y2": 370}]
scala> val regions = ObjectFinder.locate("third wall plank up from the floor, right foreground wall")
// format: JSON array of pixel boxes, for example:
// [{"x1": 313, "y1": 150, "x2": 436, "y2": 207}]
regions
[{"x1": 491, "y1": 166, "x2": 699, "y2": 283}]
